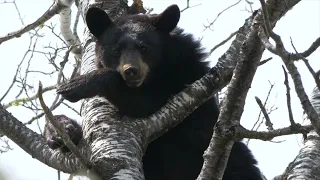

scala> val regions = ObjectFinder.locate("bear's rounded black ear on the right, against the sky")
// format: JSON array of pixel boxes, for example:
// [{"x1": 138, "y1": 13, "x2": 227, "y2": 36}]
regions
[{"x1": 155, "y1": 4, "x2": 180, "y2": 33}]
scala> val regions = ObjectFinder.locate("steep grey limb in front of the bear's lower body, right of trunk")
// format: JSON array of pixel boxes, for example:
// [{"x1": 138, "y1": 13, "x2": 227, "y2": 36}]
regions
[{"x1": 197, "y1": 28, "x2": 264, "y2": 180}]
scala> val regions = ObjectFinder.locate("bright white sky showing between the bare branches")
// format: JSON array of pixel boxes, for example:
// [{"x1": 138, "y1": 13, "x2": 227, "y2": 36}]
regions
[{"x1": 0, "y1": 0, "x2": 320, "y2": 180}]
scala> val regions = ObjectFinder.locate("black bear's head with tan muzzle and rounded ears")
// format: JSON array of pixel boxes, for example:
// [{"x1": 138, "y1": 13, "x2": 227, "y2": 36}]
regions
[{"x1": 86, "y1": 5, "x2": 180, "y2": 87}]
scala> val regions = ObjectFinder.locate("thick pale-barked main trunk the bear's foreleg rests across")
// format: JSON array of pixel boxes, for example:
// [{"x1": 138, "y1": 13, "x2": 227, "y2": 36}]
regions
[{"x1": 79, "y1": 0, "x2": 145, "y2": 179}]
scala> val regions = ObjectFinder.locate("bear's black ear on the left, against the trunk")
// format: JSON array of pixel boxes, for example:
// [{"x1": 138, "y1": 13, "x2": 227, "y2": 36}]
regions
[{"x1": 86, "y1": 7, "x2": 114, "y2": 39}]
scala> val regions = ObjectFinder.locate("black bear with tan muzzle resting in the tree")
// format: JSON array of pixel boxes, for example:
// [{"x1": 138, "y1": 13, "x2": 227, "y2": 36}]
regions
[{"x1": 50, "y1": 5, "x2": 262, "y2": 180}]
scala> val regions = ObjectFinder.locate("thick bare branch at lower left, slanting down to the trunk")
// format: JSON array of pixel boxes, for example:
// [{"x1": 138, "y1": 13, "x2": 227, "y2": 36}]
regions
[{"x1": 0, "y1": 102, "x2": 90, "y2": 174}]
